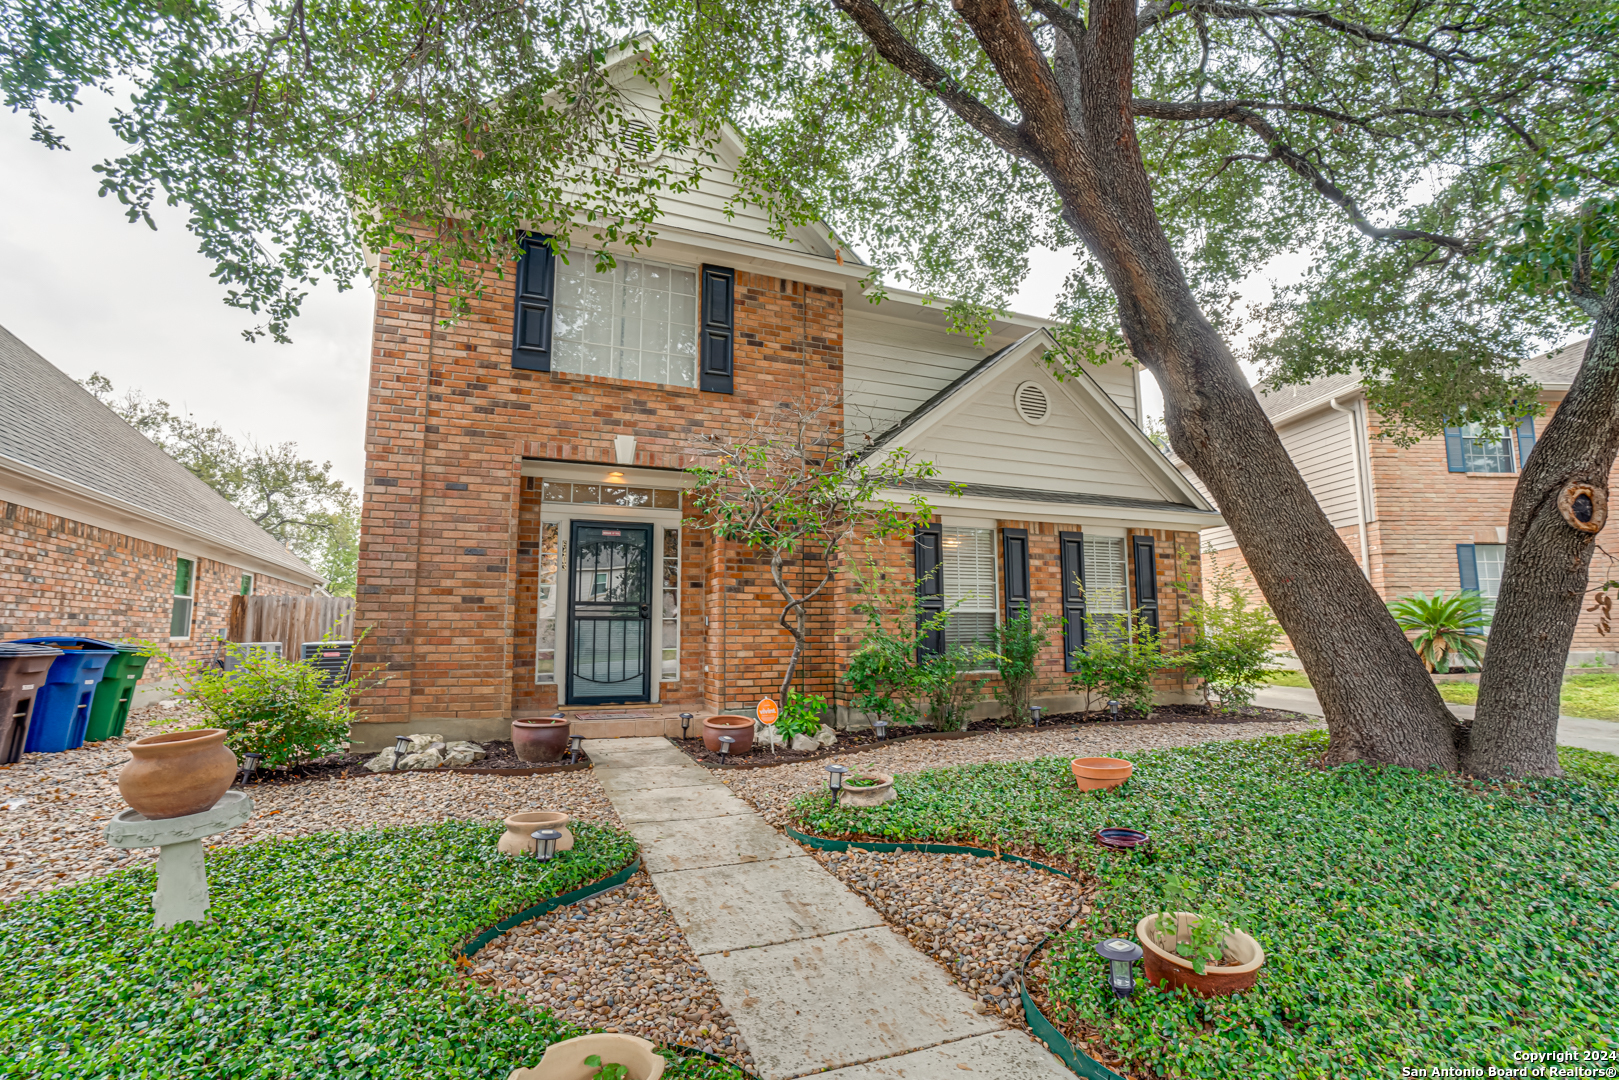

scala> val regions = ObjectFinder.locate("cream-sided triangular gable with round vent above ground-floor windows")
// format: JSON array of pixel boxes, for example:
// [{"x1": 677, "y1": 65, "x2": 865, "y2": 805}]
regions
[{"x1": 860, "y1": 329, "x2": 1219, "y2": 528}]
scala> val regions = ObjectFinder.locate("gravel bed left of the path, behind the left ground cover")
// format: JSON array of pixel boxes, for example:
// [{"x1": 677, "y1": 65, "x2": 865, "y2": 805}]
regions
[{"x1": 0, "y1": 706, "x2": 617, "y2": 899}]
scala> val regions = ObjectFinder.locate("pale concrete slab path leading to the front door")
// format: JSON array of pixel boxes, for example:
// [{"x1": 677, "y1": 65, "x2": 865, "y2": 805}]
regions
[{"x1": 584, "y1": 738, "x2": 1073, "y2": 1080}]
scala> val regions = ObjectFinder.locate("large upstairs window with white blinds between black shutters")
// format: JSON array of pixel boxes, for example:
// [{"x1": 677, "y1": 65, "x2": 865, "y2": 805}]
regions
[{"x1": 552, "y1": 257, "x2": 698, "y2": 387}]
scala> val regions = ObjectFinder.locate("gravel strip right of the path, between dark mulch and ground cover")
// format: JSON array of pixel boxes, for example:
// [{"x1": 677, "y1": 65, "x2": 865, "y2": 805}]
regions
[{"x1": 714, "y1": 716, "x2": 1321, "y2": 827}]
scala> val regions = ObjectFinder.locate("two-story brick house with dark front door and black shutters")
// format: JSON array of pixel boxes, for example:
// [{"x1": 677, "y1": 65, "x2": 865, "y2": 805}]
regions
[{"x1": 356, "y1": 52, "x2": 1219, "y2": 745}]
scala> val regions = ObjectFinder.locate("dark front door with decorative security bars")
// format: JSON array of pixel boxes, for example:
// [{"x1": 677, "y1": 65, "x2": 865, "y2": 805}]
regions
[{"x1": 567, "y1": 521, "x2": 652, "y2": 704}]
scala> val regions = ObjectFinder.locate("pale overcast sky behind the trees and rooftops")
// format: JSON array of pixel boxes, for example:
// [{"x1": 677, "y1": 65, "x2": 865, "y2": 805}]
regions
[{"x1": 0, "y1": 94, "x2": 1301, "y2": 489}]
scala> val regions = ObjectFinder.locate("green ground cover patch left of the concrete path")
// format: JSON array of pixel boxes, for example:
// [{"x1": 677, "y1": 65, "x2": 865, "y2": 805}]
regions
[{"x1": 0, "y1": 821, "x2": 743, "y2": 1080}]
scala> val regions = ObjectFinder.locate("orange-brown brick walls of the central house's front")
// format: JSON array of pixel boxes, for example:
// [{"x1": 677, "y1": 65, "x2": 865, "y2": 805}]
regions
[{"x1": 356, "y1": 249, "x2": 1198, "y2": 730}]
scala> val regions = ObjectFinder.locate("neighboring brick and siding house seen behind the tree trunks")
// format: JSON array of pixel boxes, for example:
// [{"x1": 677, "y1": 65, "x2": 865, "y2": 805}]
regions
[{"x1": 1188, "y1": 342, "x2": 1619, "y2": 661}]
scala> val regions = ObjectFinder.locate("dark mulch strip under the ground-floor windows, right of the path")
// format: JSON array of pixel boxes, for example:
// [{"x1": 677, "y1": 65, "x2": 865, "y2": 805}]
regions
[{"x1": 669, "y1": 704, "x2": 1307, "y2": 769}]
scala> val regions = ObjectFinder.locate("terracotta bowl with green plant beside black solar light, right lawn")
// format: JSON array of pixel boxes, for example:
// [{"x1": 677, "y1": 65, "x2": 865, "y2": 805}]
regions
[{"x1": 1135, "y1": 874, "x2": 1264, "y2": 997}]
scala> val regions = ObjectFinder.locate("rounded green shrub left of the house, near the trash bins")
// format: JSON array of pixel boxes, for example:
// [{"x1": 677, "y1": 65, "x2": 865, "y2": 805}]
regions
[{"x1": 181, "y1": 641, "x2": 356, "y2": 767}]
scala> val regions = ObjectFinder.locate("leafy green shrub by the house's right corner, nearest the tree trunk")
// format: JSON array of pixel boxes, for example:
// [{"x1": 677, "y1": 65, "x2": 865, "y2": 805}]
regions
[{"x1": 1174, "y1": 553, "x2": 1282, "y2": 709}]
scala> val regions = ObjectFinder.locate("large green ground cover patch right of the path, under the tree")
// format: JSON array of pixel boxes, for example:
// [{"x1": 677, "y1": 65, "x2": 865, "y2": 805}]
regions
[{"x1": 795, "y1": 733, "x2": 1619, "y2": 1080}]
